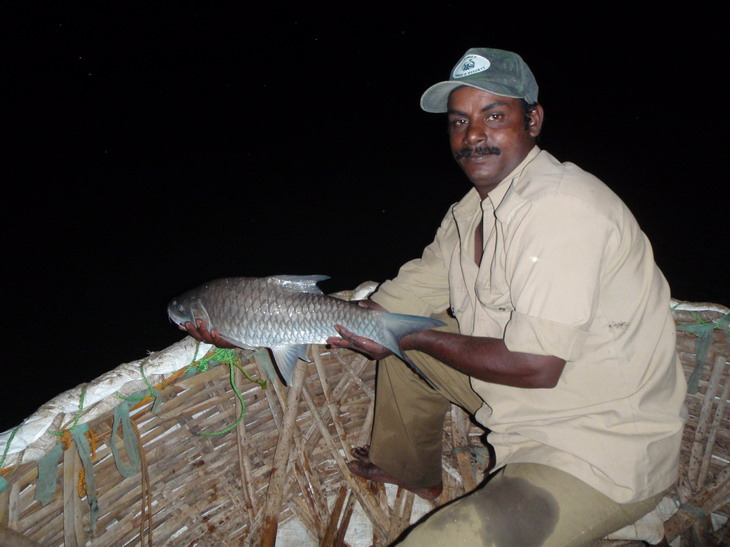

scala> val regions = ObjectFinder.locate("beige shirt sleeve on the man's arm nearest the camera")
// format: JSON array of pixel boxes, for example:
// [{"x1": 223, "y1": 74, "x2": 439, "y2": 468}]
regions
[{"x1": 504, "y1": 195, "x2": 618, "y2": 361}]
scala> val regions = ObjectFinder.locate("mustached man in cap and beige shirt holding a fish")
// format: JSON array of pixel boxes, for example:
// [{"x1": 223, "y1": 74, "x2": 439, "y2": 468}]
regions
[{"x1": 182, "y1": 48, "x2": 685, "y2": 546}]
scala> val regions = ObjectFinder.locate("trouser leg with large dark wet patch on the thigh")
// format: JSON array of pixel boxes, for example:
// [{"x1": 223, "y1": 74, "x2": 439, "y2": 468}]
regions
[{"x1": 401, "y1": 463, "x2": 662, "y2": 547}]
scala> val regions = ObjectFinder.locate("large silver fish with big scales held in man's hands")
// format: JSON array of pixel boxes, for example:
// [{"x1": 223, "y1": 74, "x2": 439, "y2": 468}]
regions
[{"x1": 167, "y1": 275, "x2": 444, "y2": 387}]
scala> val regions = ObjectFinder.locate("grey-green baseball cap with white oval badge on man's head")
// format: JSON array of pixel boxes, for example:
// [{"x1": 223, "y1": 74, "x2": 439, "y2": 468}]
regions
[{"x1": 421, "y1": 48, "x2": 538, "y2": 112}]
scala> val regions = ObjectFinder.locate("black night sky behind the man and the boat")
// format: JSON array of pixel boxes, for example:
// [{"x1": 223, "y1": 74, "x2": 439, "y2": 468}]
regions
[{"x1": 0, "y1": 2, "x2": 730, "y2": 431}]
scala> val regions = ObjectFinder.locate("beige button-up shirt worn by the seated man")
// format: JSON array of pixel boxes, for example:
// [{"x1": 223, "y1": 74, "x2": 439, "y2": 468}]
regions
[{"x1": 373, "y1": 147, "x2": 686, "y2": 503}]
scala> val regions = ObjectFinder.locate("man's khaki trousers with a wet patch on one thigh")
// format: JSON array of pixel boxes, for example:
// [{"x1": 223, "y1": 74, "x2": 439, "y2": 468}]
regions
[{"x1": 370, "y1": 318, "x2": 663, "y2": 547}]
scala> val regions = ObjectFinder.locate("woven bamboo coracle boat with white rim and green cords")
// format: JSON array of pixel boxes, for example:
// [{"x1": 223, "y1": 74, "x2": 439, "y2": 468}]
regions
[{"x1": 0, "y1": 302, "x2": 730, "y2": 547}]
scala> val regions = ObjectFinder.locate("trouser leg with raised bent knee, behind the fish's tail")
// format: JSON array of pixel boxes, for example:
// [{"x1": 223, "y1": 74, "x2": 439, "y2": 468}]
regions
[{"x1": 370, "y1": 314, "x2": 482, "y2": 487}]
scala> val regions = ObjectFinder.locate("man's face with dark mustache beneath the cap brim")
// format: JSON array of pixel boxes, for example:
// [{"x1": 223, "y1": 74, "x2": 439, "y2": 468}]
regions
[{"x1": 448, "y1": 86, "x2": 542, "y2": 199}]
